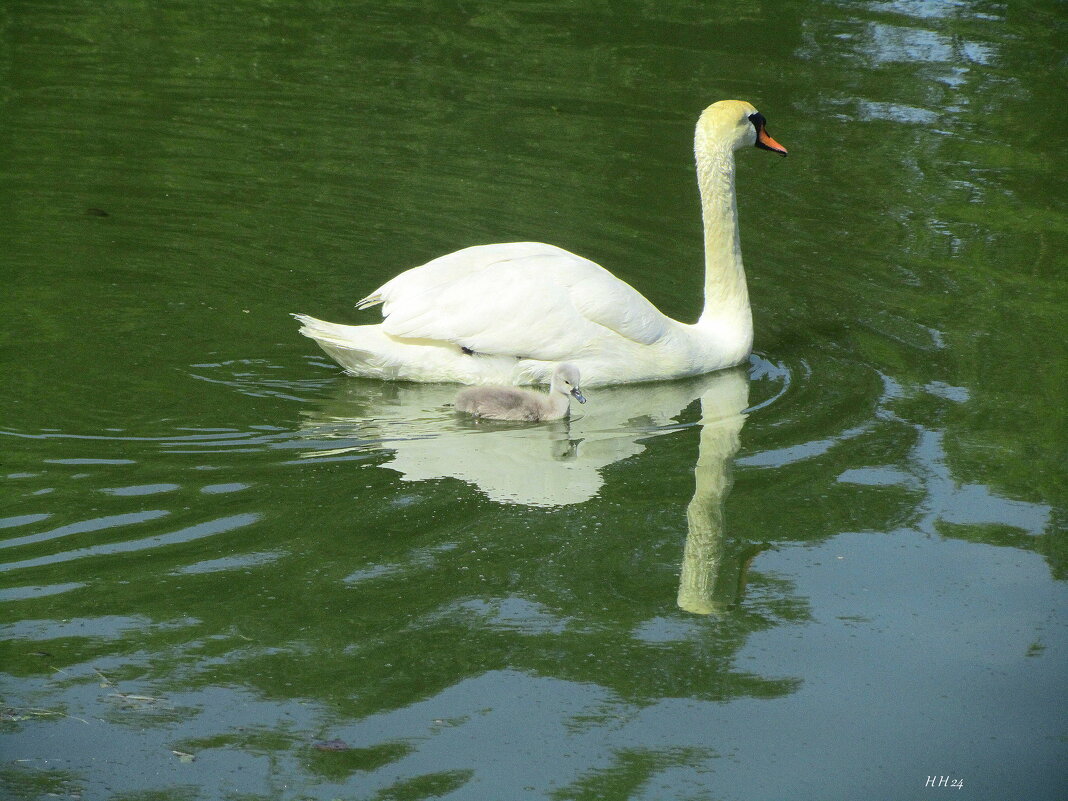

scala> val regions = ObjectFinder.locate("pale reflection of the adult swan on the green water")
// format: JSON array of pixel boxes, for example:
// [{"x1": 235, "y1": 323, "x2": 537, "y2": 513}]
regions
[{"x1": 301, "y1": 368, "x2": 749, "y2": 614}]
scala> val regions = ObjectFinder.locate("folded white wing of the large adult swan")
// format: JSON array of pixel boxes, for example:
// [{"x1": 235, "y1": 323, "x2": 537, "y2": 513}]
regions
[{"x1": 359, "y1": 242, "x2": 669, "y2": 361}]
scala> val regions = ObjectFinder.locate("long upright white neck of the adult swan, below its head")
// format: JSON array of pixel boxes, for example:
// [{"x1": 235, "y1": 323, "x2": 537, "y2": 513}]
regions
[{"x1": 695, "y1": 135, "x2": 753, "y2": 341}]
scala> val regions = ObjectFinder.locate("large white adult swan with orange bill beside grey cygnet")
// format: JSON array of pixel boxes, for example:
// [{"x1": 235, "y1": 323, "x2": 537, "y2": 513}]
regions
[{"x1": 294, "y1": 100, "x2": 786, "y2": 386}]
